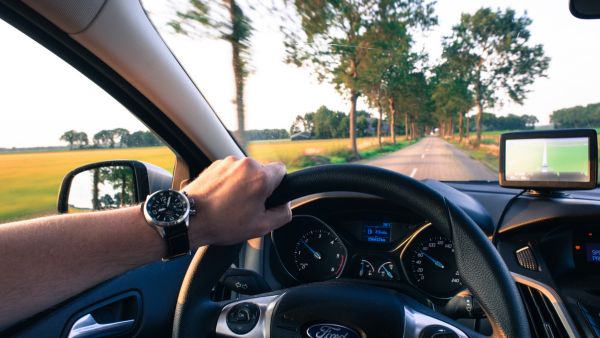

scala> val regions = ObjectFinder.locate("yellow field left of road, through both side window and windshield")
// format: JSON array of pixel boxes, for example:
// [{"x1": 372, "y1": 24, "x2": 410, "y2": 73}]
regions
[{"x1": 0, "y1": 138, "x2": 408, "y2": 223}]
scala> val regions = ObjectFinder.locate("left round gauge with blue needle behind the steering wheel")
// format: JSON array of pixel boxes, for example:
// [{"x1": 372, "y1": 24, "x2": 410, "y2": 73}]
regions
[{"x1": 294, "y1": 228, "x2": 348, "y2": 282}]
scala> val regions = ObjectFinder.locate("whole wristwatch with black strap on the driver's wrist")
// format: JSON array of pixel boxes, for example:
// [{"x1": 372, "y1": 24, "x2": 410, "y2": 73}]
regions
[{"x1": 142, "y1": 189, "x2": 196, "y2": 261}]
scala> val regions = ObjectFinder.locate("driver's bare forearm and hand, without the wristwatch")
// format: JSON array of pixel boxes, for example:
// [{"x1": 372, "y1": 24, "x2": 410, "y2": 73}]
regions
[{"x1": 0, "y1": 157, "x2": 291, "y2": 329}]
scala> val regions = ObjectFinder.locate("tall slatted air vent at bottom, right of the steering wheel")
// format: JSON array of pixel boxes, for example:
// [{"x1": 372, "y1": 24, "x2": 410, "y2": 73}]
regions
[{"x1": 517, "y1": 283, "x2": 569, "y2": 338}]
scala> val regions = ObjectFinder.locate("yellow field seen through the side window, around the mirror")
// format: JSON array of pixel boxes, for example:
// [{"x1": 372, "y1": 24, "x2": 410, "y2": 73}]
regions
[{"x1": 0, "y1": 147, "x2": 175, "y2": 223}]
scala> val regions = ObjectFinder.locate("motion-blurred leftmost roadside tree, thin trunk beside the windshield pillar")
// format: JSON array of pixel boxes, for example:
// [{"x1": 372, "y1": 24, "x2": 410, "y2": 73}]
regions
[{"x1": 169, "y1": 0, "x2": 253, "y2": 147}]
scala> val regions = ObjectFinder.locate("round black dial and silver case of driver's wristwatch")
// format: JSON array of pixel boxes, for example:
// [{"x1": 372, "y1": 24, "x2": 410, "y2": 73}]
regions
[{"x1": 146, "y1": 190, "x2": 189, "y2": 225}]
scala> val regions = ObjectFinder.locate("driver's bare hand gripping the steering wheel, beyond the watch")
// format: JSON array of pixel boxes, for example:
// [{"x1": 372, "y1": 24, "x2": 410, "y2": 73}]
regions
[{"x1": 183, "y1": 156, "x2": 292, "y2": 248}]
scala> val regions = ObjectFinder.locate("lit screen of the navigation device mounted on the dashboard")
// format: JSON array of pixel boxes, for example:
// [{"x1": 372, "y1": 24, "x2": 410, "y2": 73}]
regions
[{"x1": 504, "y1": 137, "x2": 590, "y2": 182}]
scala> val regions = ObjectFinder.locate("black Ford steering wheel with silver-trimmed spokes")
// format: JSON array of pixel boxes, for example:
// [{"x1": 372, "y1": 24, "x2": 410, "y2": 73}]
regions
[{"x1": 173, "y1": 164, "x2": 530, "y2": 338}]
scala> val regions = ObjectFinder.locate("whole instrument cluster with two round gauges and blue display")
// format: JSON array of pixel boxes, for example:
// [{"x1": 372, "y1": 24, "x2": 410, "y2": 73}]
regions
[{"x1": 272, "y1": 213, "x2": 464, "y2": 299}]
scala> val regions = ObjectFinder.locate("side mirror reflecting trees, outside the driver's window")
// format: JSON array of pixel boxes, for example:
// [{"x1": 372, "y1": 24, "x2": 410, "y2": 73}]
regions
[{"x1": 58, "y1": 160, "x2": 173, "y2": 214}]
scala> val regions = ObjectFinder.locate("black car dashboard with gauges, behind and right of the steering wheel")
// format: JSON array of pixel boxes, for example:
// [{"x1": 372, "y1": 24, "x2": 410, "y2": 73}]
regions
[{"x1": 264, "y1": 187, "x2": 600, "y2": 337}]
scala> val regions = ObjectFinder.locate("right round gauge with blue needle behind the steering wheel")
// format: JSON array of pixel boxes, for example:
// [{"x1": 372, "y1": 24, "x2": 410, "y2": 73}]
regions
[{"x1": 402, "y1": 226, "x2": 463, "y2": 298}]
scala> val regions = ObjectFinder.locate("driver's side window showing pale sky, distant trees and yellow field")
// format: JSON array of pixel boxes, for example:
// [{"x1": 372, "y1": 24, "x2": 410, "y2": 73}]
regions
[{"x1": 0, "y1": 20, "x2": 175, "y2": 224}]
